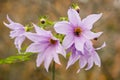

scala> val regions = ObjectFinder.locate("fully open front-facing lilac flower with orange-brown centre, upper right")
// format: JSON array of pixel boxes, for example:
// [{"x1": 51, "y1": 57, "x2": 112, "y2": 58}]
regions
[{"x1": 54, "y1": 9, "x2": 102, "y2": 52}]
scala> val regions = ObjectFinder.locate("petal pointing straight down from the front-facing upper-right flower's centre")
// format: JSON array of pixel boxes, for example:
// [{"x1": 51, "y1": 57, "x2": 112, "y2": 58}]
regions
[{"x1": 75, "y1": 35, "x2": 86, "y2": 53}]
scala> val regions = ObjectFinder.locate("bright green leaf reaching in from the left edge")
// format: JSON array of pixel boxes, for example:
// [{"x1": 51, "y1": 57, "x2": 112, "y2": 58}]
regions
[{"x1": 0, "y1": 53, "x2": 33, "y2": 64}]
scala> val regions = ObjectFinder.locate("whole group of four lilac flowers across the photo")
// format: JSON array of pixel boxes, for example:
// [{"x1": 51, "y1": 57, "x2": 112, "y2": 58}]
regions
[{"x1": 4, "y1": 8, "x2": 105, "y2": 72}]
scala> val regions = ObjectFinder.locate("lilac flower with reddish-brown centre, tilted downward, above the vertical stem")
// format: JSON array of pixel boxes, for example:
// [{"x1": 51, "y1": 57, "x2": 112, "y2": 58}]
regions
[{"x1": 26, "y1": 24, "x2": 66, "y2": 71}]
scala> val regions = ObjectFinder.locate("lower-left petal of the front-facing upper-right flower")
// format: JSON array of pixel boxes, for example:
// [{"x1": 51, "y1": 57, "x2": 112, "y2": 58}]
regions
[{"x1": 63, "y1": 34, "x2": 74, "y2": 49}]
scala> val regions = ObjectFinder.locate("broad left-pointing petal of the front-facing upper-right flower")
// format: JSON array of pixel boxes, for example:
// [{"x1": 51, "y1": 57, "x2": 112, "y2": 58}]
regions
[{"x1": 54, "y1": 21, "x2": 72, "y2": 34}]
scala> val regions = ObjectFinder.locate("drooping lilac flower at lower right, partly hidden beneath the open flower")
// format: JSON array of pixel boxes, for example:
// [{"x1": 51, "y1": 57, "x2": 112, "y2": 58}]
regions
[{"x1": 67, "y1": 41, "x2": 106, "y2": 72}]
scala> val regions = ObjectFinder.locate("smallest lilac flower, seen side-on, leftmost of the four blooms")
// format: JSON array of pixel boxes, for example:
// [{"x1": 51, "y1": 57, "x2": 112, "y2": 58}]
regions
[{"x1": 4, "y1": 15, "x2": 25, "y2": 52}]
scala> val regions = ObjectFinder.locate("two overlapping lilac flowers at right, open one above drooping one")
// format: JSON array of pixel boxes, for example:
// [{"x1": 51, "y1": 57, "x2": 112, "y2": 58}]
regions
[{"x1": 54, "y1": 9, "x2": 105, "y2": 72}]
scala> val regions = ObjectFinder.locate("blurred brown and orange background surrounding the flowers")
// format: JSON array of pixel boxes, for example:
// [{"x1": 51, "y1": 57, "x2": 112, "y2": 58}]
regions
[{"x1": 0, "y1": 0, "x2": 120, "y2": 80}]
